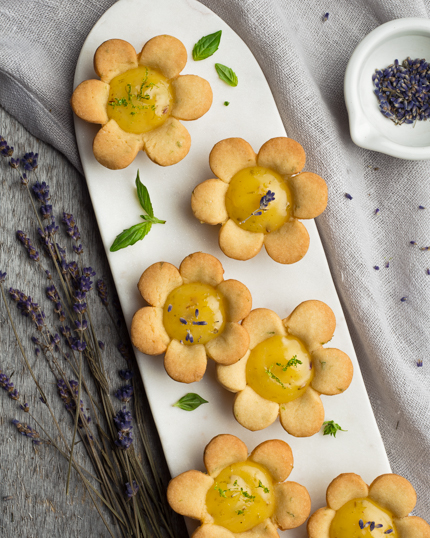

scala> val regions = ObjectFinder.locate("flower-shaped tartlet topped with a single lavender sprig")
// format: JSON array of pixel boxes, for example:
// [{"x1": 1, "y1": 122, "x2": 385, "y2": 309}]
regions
[{"x1": 191, "y1": 137, "x2": 327, "y2": 263}]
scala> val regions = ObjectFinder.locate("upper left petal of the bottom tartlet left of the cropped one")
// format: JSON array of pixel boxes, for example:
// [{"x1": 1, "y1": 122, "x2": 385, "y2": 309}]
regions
[{"x1": 203, "y1": 434, "x2": 248, "y2": 478}]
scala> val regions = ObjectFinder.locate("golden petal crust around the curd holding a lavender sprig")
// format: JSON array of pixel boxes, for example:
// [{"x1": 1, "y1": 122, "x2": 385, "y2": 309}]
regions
[{"x1": 191, "y1": 137, "x2": 327, "y2": 264}]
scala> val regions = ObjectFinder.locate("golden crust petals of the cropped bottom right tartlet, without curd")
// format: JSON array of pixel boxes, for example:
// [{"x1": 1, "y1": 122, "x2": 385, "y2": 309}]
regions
[{"x1": 307, "y1": 473, "x2": 430, "y2": 538}]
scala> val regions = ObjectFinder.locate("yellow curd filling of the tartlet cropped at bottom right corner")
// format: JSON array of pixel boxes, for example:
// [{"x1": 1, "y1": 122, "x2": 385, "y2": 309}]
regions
[{"x1": 330, "y1": 498, "x2": 398, "y2": 538}]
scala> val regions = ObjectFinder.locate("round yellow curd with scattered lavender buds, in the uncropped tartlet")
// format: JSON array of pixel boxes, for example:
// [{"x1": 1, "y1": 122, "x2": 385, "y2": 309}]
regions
[{"x1": 163, "y1": 282, "x2": 226, "y2": 346}]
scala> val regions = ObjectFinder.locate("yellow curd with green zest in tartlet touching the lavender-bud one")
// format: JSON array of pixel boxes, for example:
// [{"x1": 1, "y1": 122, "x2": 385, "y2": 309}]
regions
[{"x1": 246, "y1": 335, "x2": 314, "y2": 404}]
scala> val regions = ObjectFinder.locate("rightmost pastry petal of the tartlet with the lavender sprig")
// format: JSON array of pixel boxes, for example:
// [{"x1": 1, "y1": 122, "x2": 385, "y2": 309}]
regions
[{"x1": 288, "y1": 172, "x2": 328, "y2": 219}]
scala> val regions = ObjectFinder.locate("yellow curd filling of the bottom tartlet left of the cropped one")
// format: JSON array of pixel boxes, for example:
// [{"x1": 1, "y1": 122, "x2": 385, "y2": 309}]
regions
[{"x1": 206, "y1": 461, "x2": 275, "y2": 532}]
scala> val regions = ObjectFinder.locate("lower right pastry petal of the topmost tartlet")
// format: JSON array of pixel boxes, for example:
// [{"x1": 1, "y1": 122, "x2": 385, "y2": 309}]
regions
[{"x1": 141, "y1": 117, "x2": 191, "y2": 166}]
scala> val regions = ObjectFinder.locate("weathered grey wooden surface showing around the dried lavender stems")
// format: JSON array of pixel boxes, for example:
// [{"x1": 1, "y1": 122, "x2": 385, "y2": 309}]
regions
[{"x1": 0, "y1": 108, "x2": 188, "y2": 538}]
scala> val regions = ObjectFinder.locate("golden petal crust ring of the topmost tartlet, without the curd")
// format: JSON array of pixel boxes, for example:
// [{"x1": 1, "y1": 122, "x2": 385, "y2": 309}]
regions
[{"x1": 71, "y1": 35, "x2": 213, "y2": 170}]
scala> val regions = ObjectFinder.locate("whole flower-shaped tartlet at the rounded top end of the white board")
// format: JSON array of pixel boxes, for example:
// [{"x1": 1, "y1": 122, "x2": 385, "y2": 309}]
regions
[{"x1": 71, "y1": 35, "x2": 212, "y2": 170}]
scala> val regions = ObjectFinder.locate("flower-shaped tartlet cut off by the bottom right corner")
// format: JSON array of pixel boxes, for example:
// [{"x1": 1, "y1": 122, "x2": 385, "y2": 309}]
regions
[{"x1": 308, "y1": 473, "x2": 430, "y2": 538}]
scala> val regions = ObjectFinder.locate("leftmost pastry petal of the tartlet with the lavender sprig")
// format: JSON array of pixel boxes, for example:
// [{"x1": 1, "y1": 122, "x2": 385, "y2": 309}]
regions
[{"x1": 191, "y1": 179, "x2": 228, "y2": 224}]
